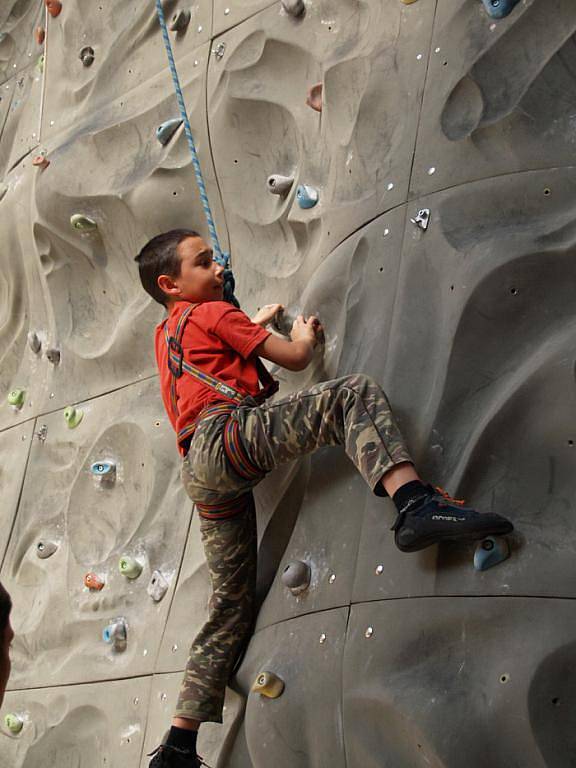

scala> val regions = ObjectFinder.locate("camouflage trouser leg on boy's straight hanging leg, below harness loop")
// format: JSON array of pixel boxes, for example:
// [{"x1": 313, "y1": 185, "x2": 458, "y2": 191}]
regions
[{"x1": 174, "y1": 501, "x2": 257, "y2": 723}]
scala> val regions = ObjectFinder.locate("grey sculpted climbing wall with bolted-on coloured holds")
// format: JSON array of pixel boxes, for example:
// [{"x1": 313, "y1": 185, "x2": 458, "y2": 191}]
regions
[{"x1": 0, "y1": 0, "x2": 576, "y2": 768}]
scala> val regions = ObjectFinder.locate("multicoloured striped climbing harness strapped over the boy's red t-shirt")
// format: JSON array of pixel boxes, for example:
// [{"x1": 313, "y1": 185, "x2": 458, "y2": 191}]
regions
[{"x1": 164, "y1": 304, "x2": 279, "y2": 450}]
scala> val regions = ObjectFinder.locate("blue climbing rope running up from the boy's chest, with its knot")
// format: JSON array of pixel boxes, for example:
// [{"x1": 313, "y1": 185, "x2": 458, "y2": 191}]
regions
[{"x1": 156, "y1": 0, "x2": 240, "y2": 307}]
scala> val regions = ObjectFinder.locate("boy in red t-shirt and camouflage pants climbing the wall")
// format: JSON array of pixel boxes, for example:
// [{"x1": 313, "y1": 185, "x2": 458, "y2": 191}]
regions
[{"x1": 136, "y1": 229, "x2": 513, "y2": 768}]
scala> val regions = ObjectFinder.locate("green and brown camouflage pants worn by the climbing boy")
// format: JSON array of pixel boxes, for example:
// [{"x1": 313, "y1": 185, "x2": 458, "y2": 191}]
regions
[{"x1": 175, "y1": 375, "x2": 411, "y2": 723}]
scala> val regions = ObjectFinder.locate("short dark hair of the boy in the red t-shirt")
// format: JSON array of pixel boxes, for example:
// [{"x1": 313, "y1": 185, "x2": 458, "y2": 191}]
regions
[{"x1": 135, "y1": 229, "x2": 202, "y2": 306}]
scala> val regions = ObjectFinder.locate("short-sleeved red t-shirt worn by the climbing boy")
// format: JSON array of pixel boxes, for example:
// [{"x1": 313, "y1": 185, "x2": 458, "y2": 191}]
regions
[{"x1": 154, "y1": 301, "x2": 270, "y2": 455}]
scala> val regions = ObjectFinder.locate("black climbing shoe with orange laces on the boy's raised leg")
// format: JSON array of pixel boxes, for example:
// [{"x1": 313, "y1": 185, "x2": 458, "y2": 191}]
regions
[{"x1": 392, "y1": 485, "x2": 514, "y2": 552}]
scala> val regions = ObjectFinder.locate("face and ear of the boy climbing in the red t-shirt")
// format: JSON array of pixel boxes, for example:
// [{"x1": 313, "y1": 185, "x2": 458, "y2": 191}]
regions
[{"x1": 158, "y1": 237, "x2": 224, "y2": 302}]
